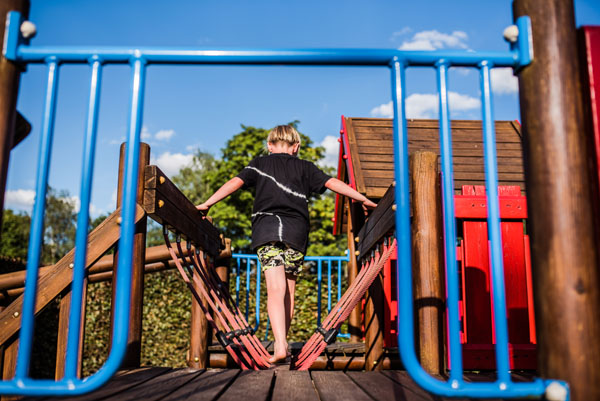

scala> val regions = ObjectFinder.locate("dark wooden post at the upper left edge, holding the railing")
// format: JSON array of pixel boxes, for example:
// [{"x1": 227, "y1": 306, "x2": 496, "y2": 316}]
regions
[{"x1": 0, "y1": 0, "x2": 29, "y2": 234}]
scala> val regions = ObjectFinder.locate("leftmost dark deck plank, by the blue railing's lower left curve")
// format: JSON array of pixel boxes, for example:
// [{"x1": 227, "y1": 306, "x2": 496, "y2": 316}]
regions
[{"x1": 60, "y1": 367, "x2": 171, "y2": 401}]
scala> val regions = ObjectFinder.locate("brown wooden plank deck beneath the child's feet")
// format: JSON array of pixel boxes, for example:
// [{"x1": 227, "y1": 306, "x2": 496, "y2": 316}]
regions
[{"x1": 19, "y1": 365, "x2": 527, "y2": 401}]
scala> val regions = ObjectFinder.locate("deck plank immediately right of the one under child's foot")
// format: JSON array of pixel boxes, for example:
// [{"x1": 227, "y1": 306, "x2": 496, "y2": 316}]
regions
[{"x1": 311, "y1": 371, "x2": 372, "y2": 401}]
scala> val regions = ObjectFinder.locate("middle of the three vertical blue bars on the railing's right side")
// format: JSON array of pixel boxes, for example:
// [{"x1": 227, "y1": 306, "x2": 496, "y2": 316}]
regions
[{"x1": 436, "y1": 61, "x2": 463, "y2": 383}]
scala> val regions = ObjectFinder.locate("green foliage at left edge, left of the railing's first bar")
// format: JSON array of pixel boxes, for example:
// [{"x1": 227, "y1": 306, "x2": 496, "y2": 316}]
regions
[{"x1": 0, "y1": 209, "x2": 31, "y2": 261}]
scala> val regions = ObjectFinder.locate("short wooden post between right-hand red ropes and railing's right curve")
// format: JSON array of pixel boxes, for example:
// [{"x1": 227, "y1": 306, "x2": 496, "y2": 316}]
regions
[{"x1": 365, "y1": 248, "x2": 384, "y2": 371}]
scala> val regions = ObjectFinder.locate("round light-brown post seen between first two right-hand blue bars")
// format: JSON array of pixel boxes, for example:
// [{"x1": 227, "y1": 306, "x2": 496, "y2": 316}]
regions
[{"x1": 410, "y1": 152, "x2": 444, "y2": 374}]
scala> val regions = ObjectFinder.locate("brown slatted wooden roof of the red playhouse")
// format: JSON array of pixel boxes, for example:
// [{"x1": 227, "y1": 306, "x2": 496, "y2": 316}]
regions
[{"x1": 346, "y1": 117, "x2": 525, "y2": 199}]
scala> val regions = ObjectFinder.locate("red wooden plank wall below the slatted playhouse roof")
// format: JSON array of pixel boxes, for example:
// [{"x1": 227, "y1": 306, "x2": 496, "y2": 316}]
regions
[{"x1": 455, "y1": 186, "x2": 536, "y2": 369}]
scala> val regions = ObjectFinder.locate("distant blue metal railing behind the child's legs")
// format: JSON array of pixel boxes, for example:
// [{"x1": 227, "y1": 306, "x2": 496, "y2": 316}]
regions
[{"x1": 232, "y1": 253, "x2": 350, "y2": 340}]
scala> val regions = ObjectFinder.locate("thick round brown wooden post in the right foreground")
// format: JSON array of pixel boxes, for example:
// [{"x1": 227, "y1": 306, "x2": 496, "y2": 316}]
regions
[{"x1": 513, "y1": 0, "x2": 600, "y2": 401}]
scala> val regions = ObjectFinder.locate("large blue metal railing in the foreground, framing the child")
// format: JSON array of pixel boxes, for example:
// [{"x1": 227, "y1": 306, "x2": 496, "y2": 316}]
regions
[{"x1": 0, "y1": 8, "x2": 566, "y2": 398}]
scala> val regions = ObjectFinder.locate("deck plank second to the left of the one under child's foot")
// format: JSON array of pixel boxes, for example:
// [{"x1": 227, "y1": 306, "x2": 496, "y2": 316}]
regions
[{"x1": 163, "y1": 369, "x2": 240, "y2": 401}]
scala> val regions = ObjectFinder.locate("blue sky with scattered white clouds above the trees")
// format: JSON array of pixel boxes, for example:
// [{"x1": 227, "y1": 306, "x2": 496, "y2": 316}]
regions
[{"x1": 5, "y1": 0, "x2": 600, "y2": 216}]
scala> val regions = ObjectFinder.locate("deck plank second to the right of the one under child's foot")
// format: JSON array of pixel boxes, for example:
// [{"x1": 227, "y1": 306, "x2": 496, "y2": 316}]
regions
[{"x1": 346, "y1": 372, "x2": 432, "y2": 401}]
